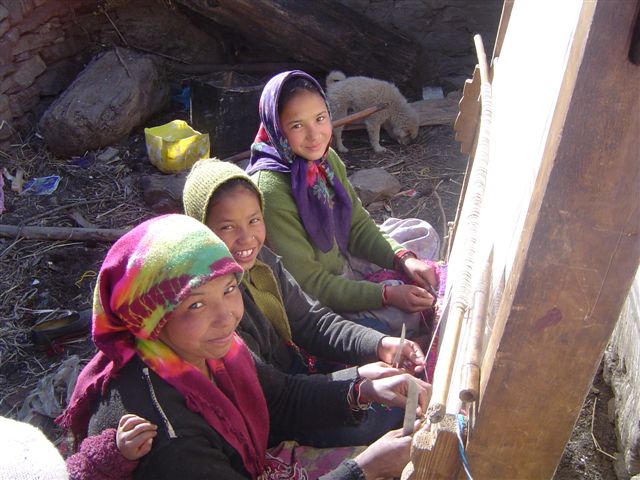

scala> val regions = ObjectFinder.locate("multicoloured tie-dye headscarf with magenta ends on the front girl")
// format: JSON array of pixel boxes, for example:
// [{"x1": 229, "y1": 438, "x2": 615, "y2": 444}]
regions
[{"x1": 57, "y1": 215, "x2": 269, "y2": 478}]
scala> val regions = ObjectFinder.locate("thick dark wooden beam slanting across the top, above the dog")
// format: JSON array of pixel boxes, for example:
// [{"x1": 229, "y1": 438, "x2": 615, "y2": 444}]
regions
[{"x1": 178, "y1": 0, "x2": 419, "y2": 92}]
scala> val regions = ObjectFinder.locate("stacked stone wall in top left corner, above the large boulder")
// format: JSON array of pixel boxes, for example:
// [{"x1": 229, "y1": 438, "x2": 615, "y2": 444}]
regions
[{"x1": 0, "y1": 0, "x2": 222, "y2": 145}]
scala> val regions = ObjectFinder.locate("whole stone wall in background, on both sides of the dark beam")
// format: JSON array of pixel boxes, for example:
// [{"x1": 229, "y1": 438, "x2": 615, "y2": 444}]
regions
[{"x1": 0, "y1": 0, "x2": 502, "y2": 144}]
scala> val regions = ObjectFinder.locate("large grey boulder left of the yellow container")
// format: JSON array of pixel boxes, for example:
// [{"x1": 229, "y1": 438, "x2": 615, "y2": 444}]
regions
[{"x1": 38, "y1": 48, "x2": 169, "y2": 155}]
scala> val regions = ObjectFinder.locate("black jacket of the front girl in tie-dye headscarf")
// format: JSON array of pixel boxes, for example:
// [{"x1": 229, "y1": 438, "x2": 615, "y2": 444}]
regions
[{"x1": 89, "y1": 358, "x2": 362, "y2": 480}]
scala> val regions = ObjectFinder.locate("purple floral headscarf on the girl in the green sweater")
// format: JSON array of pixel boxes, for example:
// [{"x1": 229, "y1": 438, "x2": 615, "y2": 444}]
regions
[{"x1": 247, "y1": 70, "x2": 352, "y2": 254}]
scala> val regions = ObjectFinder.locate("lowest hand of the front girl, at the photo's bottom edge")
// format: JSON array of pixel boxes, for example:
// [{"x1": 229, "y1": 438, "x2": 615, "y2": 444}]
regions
[{"x1": 354, "y1": 429, "x2": 411, "y2": 478}]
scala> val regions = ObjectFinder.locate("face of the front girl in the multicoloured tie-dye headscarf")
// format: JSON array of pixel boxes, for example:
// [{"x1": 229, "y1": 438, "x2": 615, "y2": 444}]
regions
[{"x1": 158, "y1": 274, "x2": 244, "y2": 374}]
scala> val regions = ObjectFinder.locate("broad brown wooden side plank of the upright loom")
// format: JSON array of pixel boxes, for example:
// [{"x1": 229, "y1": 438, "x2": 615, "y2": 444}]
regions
[{"x1": 468, "y1": 0, "x2": 640, "y2": 479}]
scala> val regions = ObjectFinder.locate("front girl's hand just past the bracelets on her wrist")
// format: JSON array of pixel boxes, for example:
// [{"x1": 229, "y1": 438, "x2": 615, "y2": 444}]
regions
[{"x1": 360, "y1": 373, "x2": 431, "y2": 415}]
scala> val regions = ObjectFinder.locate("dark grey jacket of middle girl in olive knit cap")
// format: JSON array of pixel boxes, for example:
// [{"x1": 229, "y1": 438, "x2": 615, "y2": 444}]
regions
[{"x1": 238, "y1": 247, "x2": 384, "y2": 378}]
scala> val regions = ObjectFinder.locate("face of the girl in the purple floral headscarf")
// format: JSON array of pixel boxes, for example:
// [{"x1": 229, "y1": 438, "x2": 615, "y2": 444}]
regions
[{"x1": 280, "y1": 90, "x2": 332, "y2": 161}]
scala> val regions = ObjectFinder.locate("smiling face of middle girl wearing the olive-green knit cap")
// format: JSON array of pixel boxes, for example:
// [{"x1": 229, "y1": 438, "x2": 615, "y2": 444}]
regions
[{"x1": 206, "y1": 185, "x2": 267, "y2": 270}]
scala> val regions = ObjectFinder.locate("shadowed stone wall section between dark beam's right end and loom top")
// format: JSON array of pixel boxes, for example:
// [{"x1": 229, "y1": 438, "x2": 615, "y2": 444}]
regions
[{"x1": 340, "y1": 0, "x2": 503, "y2": 92}]
